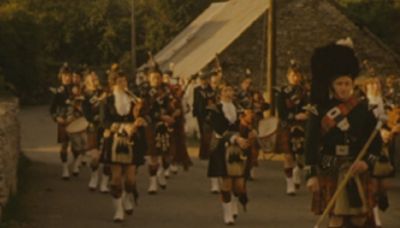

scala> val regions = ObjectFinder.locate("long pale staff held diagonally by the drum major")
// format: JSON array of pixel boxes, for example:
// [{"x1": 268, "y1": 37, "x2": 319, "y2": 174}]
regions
[{"x1": 314, "y1": 121, "x2": 383, "y2": 228}]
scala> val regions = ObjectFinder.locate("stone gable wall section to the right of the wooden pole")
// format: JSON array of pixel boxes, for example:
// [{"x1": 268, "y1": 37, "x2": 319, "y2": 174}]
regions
[{"x1": 276, "y1": 0, "x2": 400, "y2": 83}]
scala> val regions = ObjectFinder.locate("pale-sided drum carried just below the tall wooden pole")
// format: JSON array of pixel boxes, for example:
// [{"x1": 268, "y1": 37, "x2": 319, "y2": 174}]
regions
[{"x1": 258, "y1": 117, "x2": 279, "y2": 153}]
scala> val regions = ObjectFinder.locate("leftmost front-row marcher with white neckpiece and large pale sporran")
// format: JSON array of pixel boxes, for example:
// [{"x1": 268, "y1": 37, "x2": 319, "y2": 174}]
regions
[{"x1": 104, "y1": 73, "x2": 146, "y2": 222}]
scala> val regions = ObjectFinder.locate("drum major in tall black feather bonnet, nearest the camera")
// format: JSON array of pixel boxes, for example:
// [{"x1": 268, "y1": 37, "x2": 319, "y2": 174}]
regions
[{"x1": 305, "y1": 41, "x2": 382, "y2": 227}]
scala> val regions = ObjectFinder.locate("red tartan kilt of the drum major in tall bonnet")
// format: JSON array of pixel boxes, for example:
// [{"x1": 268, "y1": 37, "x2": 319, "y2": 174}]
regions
[{"x1": 311, "y1": 172, "x2": 377, "y2": 217}]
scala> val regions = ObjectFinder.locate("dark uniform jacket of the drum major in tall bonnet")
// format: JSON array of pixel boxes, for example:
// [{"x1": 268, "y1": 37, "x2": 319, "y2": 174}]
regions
[{"x1": 305, "y1": 99, "x2": 382, "y2": 175}]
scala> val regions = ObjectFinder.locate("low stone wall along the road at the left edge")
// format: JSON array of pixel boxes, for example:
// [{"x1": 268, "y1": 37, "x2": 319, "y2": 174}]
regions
[{"x1": 0, "y1": 97, "x2": 20, "y2": 216}]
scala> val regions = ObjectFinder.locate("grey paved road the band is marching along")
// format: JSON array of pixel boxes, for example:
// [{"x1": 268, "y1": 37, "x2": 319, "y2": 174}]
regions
[{"x1": 11, "y1": 107, "x2": 400, "y2": 228}]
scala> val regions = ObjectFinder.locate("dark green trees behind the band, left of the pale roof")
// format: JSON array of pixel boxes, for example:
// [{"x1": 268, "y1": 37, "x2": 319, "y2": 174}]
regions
[{"x1": 0, "y1": 0, "x2": 212, "y2": 103}]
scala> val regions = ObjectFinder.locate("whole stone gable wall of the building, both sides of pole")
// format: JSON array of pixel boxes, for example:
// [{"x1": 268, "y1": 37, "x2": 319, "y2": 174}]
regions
[{"x1": 205, "y1": 0, "x2": 400, "y2": 88}]
